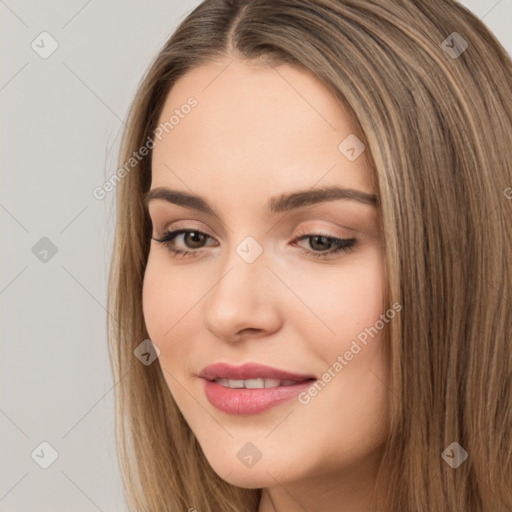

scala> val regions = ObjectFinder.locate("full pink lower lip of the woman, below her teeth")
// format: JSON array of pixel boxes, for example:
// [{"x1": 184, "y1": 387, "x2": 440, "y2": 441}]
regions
[{"x1": 204, "y1": 380, "x2": 314, "y2": 416}]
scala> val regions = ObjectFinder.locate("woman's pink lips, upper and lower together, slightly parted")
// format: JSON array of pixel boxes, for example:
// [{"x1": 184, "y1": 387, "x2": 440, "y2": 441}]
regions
[{"x1": 199, "y1": 363, "x2": 316, "y2": 416}]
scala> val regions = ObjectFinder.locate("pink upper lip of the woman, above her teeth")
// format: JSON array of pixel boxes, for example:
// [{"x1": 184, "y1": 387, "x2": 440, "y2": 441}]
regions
[{"x1": 199, "y1": 363, "x2": 315, "y2": 382}]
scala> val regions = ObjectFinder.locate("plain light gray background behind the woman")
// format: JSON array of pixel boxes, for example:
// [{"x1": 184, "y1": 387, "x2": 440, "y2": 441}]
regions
[{"x1": 0, "y1": 0, "x2": 512, "y2": 512}]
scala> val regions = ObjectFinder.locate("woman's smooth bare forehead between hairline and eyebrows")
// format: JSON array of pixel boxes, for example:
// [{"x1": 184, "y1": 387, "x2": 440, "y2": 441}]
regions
[{"x1": 152, "y1": 59, "x2": 372, "y2": 202}]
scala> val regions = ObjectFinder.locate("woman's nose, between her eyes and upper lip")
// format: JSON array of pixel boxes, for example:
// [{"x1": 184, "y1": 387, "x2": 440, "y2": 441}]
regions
[{"x1": 203, "y1": 244, "x2": 282, "y2": 342}]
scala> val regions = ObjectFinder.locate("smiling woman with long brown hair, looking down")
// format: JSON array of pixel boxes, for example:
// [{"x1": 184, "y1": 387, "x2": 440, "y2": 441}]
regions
[{"x1": 109, "y1": 0, "x2": 512, "y2": 512}]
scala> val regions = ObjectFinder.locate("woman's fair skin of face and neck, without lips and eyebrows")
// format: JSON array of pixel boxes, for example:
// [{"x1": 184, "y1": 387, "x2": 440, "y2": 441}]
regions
[{"x1": 143, "y1": 58, "x2": 389, "y2": 512}]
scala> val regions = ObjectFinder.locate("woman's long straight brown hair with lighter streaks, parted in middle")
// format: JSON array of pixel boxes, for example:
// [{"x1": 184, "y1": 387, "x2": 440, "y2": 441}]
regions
[{"x1": 107, "y1": 0, "x2": 512, "y2": 512}]
